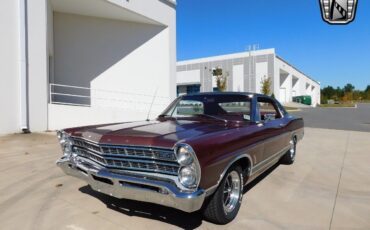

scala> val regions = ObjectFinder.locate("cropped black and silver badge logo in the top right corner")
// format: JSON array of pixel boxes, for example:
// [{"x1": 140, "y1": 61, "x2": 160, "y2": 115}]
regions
[{"x1": 320, "y1": 0, "x2": 357, "y2": 24}]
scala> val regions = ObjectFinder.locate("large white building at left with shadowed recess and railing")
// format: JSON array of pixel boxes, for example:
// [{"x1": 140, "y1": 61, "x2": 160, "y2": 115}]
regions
[{"x1": 0, "y1": 0, "x2": 176, "y2": 134}]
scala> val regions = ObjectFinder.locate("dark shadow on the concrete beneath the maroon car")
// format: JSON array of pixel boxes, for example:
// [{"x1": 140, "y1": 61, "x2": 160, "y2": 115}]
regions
[{"x1": 79, "y1": 164, "x2": 279, "y2": 229}]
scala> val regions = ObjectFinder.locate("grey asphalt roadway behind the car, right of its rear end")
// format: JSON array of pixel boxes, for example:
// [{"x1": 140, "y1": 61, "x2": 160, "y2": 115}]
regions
[{"x1": 291, "y1": 104, "x2": 370, "y2": 132}]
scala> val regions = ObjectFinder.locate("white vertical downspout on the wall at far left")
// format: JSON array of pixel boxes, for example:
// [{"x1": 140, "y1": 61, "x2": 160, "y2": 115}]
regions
[{"x1": 19, "y1": 0, "x2": 30, "y2": 133}]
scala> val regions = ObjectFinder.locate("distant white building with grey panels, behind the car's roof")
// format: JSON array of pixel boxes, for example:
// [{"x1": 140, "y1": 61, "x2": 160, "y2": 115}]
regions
[{"x1": 177, "y1": 49, "x2": 320, "y2": 106}]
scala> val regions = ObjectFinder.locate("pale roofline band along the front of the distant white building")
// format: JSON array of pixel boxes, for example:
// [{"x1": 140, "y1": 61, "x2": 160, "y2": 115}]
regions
[{"x1": 176, "y1": 48, "x2": 275, "y2": 66}]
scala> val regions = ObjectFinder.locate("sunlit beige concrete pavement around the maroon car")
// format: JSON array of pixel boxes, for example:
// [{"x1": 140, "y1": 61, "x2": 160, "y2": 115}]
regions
[{"x1": 0, "y1": 105, "x2": 370, "y2": 230}]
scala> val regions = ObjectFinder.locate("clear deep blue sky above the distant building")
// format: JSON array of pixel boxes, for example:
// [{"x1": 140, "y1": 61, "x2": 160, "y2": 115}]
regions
[{"x1": 177, "y1": 0, "x2": 370, "y2": 90}]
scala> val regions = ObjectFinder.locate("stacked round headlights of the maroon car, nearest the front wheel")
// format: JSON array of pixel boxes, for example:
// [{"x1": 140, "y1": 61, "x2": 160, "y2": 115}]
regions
[{"x1": 175, "y1": 144, "x2": 201, "y2": 189}]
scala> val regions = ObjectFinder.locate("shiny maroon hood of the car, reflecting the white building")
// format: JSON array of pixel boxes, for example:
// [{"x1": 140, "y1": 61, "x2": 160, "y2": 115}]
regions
[{"x1": 65, "y1": 120, "x2": 240, "y2": 148}]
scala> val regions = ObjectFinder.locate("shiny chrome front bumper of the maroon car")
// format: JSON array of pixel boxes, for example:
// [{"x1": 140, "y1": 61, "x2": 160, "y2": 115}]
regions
[{"x1": 56, "y1": 156, "x2": 205, "y2": 212}]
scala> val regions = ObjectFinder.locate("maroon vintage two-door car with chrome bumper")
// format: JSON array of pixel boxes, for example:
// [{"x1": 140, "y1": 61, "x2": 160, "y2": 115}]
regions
[{"x1": 57, "y1": 93, "x2": 304, "y2": 224}]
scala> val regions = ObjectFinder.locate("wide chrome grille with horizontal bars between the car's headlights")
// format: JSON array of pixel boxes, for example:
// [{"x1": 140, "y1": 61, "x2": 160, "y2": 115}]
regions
[{"x1": 73, "y1": 138, "x2": 179, "y2": 175}]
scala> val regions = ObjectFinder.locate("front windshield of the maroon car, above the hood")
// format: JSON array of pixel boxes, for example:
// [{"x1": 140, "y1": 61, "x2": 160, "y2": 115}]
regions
[{"x1": 162, "y1": 94, "x2": 251, "y2": 120}]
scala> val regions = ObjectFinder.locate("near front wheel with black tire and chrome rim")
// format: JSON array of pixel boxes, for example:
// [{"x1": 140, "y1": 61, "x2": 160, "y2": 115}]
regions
[{"x1": 203, "y1": 165, "x2": 243, "y2": 224}]
